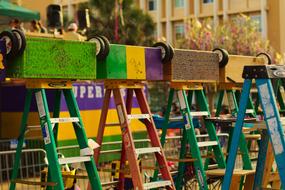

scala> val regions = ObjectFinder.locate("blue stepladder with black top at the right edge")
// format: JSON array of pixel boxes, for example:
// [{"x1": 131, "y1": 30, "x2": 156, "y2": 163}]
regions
[{"x1": 222, "y1": 65, "x2": 285, "y2": 190}]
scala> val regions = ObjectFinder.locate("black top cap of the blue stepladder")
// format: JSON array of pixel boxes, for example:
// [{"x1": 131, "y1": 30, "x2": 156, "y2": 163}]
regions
[{"x1": 242, "y1": 65, "x2": 285, "y2": 79}]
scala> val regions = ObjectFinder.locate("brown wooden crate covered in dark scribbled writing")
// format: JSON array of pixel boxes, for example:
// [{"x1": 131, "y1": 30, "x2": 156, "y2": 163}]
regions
[{"x1": 163, "y1": 49, "x2": 219, "y2": 82}]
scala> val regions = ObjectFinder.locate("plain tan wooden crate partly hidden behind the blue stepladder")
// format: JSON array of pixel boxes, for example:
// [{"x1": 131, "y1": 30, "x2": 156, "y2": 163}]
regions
[{"x1": 219, "y1": 55, "x2": 266, "y2": 83}]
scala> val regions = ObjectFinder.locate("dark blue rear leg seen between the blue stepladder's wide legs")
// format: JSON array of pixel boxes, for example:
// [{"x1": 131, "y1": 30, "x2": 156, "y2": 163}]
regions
[{"x1": 253, "y1": 130, "x2": 272, "y2": 189}]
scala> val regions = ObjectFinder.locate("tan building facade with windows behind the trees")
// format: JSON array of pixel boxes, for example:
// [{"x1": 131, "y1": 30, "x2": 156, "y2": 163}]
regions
[{"x1": 18, "y1": 0, "x2": 285, "y2": 52}]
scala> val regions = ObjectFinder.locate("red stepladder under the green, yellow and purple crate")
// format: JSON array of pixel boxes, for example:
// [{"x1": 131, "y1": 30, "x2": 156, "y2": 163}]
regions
[{"x1": 94, "y1": 81, "x2": 175, "y2": 190}]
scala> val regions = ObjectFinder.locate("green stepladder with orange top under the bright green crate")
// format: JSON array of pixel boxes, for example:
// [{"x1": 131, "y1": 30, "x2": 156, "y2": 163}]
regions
[{"x1": 10, "y1": 79, "x2": 102, "y2": 190}]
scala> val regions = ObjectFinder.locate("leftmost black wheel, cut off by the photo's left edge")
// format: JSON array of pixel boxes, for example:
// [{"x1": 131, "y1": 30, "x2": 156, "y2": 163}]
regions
[{"x1": 0, "y1": 31, "x2": 19, "y2": 60}]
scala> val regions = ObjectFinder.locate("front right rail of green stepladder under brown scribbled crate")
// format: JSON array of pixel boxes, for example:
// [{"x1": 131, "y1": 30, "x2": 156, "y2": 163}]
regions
[{"x1": 195, "y1": 90, "x2": 226, "y2": 168}]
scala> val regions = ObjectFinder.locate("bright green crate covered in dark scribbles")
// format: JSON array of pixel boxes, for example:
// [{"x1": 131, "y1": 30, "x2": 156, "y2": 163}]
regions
[{"x1": 7, "y1": 38, "x2": 96, "y2": 79}]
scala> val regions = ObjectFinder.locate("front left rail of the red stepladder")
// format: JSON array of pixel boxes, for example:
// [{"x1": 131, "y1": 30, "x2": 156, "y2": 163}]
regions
[{"x1": 113, "y1": 89, "x2": 143, "y2": 190}]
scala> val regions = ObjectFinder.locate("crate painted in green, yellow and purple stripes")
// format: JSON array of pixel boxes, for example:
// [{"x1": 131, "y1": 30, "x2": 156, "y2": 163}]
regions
[{"x1": 97, "y1": 44, "x2": 163, "y2": 80}]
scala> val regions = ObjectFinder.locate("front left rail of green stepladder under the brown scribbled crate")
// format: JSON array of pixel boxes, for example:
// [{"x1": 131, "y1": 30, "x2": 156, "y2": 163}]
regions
[{"x1": 177, "y1": 90, "x2": 208, "y2": 189}]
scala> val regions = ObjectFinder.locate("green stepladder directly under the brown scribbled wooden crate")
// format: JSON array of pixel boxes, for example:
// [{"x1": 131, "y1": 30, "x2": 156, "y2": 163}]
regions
[{"x1": 153, "y1": 82, "x2": 225, "y2": 189}]
